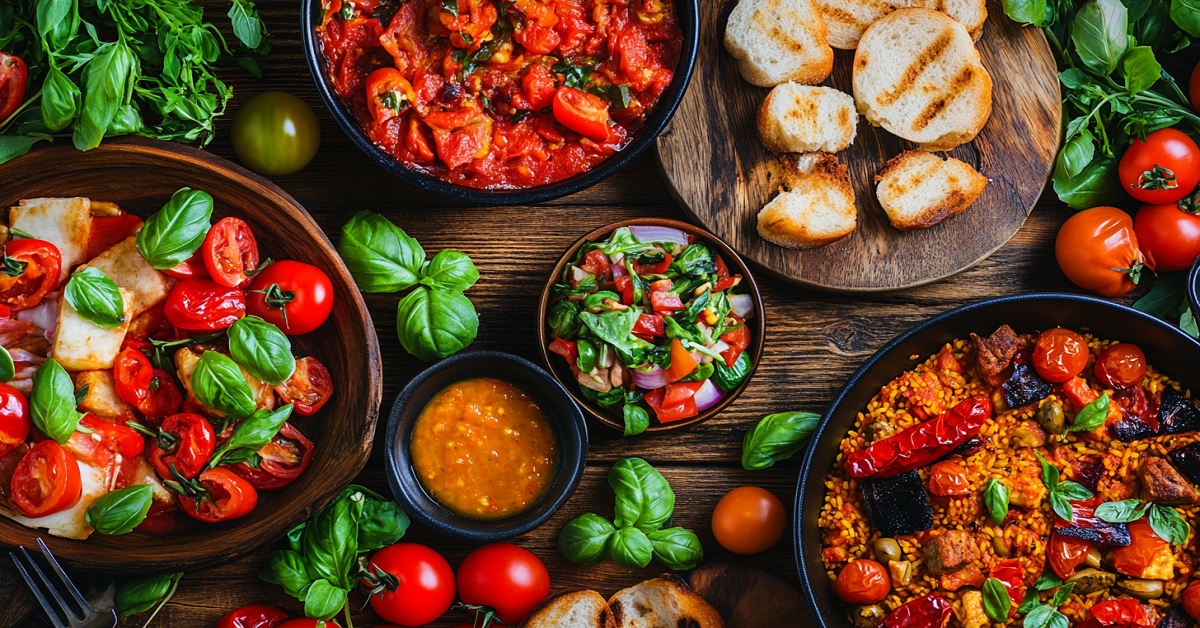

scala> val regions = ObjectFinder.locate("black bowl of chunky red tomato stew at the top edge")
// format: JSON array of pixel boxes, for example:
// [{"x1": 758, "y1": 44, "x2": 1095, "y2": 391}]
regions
[{"x1": 302, "y1": 0, "x2": 700, "y2": 205}]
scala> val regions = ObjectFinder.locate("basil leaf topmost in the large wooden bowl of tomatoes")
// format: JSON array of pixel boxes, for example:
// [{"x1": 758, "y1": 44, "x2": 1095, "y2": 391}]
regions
[{"x1": 136, "y1": 187, "x2": 212, "y2": 270}]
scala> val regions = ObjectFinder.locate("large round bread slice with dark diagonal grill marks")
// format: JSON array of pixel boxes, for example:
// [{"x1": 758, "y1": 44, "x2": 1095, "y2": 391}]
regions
[{"x1": 853, "y1": 8, "x2": 991, "y2": 150}]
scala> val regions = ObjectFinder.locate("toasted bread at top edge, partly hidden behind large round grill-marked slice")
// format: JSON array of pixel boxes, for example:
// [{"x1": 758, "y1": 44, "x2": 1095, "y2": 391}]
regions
[{"x1": 814, "y1": 0, "x2": 988, "y2": 50}]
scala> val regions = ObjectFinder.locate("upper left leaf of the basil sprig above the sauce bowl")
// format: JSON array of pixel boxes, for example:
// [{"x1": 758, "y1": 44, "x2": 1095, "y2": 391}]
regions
[{"x1": 337, "y1": 211, "x2": 427, "y2": 292}]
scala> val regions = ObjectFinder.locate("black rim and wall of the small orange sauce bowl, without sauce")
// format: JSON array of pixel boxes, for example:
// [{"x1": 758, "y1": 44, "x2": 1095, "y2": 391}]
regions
[{"x1": 383, "y1": 351, "x2": 588, "y2": 543}]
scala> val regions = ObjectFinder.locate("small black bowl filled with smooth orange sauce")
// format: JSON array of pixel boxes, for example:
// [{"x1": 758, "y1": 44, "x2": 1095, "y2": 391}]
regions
[{"x1": 385, "y1": 351, "x2": 588, "y2": 542}]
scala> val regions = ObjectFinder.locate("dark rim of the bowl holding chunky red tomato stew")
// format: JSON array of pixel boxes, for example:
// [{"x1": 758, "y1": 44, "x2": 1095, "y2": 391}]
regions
[{"x1": 300, "y1": 0, "x2": 700, "y2": 205}]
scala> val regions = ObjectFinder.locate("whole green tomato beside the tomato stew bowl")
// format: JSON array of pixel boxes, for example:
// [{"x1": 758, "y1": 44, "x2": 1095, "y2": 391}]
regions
[{"x1": 233, "y1": 91, "x2": 320, "y2": 177}]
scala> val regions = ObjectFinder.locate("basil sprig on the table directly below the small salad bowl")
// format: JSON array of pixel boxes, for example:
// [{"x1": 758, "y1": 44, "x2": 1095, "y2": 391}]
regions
[{"x1": 558, "y1": 458, "x2": 704, "y2": 572}]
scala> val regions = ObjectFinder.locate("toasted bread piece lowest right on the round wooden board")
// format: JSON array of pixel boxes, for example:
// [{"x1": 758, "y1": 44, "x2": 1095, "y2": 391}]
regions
[{"x1": 875, "y1": 150, "x2": 988, "y2": 231}]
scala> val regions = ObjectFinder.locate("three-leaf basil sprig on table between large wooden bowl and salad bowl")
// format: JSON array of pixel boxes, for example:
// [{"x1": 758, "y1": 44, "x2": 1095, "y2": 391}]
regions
[{"x1": 337, "y1": 211, "x2": 479, "y2": 361}]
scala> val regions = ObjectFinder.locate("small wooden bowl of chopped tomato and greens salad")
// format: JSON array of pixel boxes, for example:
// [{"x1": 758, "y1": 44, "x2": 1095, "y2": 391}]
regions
[{"x1": 538, "y1": 219, "x2": 766, "y2": 436}]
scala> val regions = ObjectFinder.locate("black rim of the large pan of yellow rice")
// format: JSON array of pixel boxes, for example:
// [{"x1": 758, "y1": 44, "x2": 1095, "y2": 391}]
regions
[{"x1": 792, "y1": 292, "x2": 1200, "y2": 628}]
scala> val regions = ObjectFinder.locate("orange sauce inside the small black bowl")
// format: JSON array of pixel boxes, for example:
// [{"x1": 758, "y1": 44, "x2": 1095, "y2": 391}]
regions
[{"x1": 412, "y1": 378, "x2": 558, "y2": 519}]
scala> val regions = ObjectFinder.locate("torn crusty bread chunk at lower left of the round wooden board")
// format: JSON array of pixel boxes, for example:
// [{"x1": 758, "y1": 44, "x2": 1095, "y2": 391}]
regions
[{"x1": 758, "y1": 152, "x2": 858, "y2": 249}]
